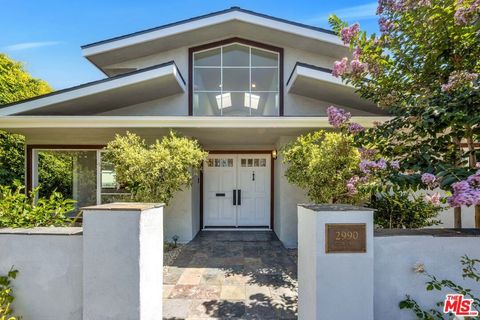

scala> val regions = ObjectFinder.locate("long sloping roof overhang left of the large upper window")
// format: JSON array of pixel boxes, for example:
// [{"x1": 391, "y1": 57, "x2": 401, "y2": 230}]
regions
[{"x1": 0, "y1": 61, "x2": 186, "y2": 116}]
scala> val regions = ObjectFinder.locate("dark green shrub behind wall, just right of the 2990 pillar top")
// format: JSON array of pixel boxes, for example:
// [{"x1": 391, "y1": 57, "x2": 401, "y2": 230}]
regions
[{"x1": 367, "y1": 191, "x2": 443, "y2": 228}]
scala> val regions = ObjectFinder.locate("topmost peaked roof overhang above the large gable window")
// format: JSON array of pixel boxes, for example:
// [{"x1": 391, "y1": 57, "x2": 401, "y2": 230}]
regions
[{"x1": 82, "y1": 7, "x2": 348, "y2": 69}]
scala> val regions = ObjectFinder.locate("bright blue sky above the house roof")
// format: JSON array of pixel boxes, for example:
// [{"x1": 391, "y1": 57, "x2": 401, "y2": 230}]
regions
[{"x1": 0, "y1": 0, "x2": 377, "y2": 90}]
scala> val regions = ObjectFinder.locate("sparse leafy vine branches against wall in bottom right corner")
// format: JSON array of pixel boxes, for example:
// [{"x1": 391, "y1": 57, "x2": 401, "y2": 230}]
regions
[{"x1": 399, "y1": 255, "x2": 480, "y2": 320}]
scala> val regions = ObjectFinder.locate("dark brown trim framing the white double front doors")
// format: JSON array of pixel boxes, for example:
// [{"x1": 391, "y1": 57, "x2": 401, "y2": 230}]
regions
[{"x1": 200, "y1": 150, "x2": 275, "y2": 231}]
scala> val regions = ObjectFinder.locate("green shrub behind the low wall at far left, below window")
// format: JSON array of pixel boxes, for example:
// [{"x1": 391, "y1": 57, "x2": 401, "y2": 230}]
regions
[{"x1": 0, "y1": 181, "x2": 75, "y2": 228}]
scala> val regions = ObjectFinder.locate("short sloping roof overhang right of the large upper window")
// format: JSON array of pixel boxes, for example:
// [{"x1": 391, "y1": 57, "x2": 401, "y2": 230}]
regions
[{"x1": 287, "y1": 63, "x2": 386, "y2": 115}]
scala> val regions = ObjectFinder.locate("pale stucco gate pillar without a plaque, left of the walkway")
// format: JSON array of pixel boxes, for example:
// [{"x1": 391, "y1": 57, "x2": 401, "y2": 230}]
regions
[{"x1": 83, "y1": 203, "x2": 163, "y2": 320}]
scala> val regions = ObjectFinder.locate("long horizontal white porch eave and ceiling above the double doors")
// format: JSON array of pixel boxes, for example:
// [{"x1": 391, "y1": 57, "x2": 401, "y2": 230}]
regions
[{"x1": 0, "y1": 116, "x2": 387, "y2": 149}]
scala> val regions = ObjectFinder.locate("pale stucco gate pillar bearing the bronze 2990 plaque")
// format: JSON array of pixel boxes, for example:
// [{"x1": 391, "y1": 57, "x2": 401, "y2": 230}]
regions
[{"x1": 298, "y1": 205, "x2": 374, "y2": 320}]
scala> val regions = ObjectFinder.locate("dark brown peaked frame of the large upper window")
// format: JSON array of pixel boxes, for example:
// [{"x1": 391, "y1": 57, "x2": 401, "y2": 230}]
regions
[{"x1": 188, "y1": 37, "x2": 284, "y2": 117}]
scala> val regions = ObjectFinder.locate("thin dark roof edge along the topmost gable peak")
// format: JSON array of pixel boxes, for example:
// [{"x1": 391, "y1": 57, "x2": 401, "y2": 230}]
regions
[{"x1": 81, "y1": 7, "x2": 336, "y2": 50}]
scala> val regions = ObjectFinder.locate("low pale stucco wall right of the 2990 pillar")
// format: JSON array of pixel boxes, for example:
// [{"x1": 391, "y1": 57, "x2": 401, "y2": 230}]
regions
[{"x1": 374, "y1": 236, "x2": 480, "y2": 320}]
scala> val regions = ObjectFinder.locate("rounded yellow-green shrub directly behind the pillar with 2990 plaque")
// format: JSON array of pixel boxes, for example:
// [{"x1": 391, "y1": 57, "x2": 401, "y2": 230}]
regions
[{"x1": 283, "y1": 130, "x2": 364, "y2": 203}]
